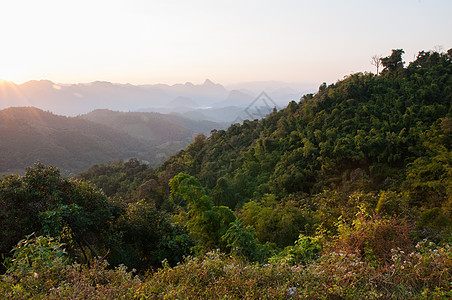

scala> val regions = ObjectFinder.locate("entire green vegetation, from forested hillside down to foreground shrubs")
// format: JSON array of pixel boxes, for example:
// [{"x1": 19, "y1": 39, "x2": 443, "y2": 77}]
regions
[{"x1": 0, "y1": 49, "x2": 452, "y2": 299}]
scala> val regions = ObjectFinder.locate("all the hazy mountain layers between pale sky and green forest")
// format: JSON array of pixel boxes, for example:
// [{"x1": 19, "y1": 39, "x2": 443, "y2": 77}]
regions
[{"x1": 0, "y1": 79, "x2": 315, "y2": 175}]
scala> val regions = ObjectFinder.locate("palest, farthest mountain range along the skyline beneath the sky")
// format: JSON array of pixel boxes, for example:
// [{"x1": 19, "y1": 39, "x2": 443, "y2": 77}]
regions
[{"x1": 0, "y1": 79, "x2": 316, "y2": 123}]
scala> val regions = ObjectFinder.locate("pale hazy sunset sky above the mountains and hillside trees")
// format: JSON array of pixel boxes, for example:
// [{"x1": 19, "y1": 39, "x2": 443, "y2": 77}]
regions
[{"x1": 0, "y1": 0, "x2": 452, "y2": 84}]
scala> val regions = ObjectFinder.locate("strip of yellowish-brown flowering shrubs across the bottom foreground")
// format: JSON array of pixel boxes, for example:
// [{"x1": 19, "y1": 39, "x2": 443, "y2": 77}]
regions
[{"x1": 0, "y1": 227, "x2": 452, "y2": 299}]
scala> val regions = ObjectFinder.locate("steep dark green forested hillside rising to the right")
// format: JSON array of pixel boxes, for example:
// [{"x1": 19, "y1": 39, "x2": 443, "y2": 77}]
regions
[{"x1": 82, "y1": 50, "x2": 452, "y2": 239}]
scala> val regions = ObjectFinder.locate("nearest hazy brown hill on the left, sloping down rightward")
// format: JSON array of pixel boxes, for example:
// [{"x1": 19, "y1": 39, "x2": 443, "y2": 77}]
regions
[{"x1": 0, "y1": 107, "x2": 151, "y2": 173}]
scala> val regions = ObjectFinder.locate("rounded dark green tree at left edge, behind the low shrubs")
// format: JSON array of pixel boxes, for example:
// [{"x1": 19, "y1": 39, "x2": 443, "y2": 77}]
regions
[{"x1": 0, "y1": 162, "x2": 112, "y2": 264}]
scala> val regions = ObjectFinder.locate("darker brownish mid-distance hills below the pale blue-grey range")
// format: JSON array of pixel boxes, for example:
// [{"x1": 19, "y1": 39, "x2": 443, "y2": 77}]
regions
[{"x1": 0, "y1": 107, "x2": 223, "y2": 175}]
